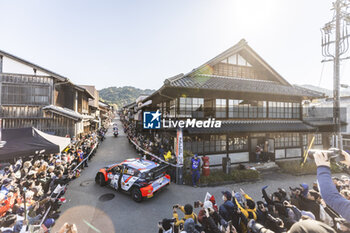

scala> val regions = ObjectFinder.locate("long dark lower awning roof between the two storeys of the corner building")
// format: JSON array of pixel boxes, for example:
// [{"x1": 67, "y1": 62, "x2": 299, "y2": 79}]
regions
[{"x1": 187, "y1": 120, "x2": 316, "y2": 134}]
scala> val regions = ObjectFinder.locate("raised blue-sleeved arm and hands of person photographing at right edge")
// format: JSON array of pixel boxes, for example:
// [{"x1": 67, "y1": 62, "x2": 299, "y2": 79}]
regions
[{"x1": 314, "y1": 151, "x2": 350, "y2": 221}]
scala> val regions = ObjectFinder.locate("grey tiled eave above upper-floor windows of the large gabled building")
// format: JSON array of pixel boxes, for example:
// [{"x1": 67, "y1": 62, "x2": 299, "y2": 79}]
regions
[{"x1": 164, "y1": 74, "x2": 324, "y2": 98}]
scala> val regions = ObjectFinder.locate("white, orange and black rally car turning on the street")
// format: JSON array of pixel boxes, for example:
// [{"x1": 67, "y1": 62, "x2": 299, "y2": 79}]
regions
[{"x1": 95, "y1": 158, "x2": 170, "y2": 202}]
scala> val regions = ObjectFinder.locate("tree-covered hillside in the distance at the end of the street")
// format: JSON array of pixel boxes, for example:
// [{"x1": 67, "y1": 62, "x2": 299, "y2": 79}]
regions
[{"x1": 99, "y1": 86, "x2": 155, "y2": 108}]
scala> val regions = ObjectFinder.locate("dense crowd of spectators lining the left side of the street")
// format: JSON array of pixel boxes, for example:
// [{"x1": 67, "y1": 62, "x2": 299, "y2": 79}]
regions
[{"x1": 0, "y1": 129, "x2": 106, "y2": 232}]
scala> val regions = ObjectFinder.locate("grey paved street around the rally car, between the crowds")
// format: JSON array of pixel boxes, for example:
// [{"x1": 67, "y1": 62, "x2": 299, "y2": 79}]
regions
[{"x1": 53, "y1": 120, "x2": 324, "y2": 233}]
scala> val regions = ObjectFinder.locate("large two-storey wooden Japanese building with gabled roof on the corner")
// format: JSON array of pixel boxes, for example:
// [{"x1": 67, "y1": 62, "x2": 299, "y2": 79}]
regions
[{"x1": 139, "y1": 40, "x2": 329, "y2": 165}]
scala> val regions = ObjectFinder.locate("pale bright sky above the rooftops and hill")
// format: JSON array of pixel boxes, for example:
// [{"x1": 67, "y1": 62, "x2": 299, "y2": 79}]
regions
[{"x1": 0, "y1": 0, "x2": 350, "y2": 89}]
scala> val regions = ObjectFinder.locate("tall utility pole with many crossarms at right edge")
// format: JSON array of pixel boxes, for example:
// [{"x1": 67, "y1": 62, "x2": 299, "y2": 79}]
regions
[{"x1": 321, "y1": 0, "x2": 350, "y2": 149}]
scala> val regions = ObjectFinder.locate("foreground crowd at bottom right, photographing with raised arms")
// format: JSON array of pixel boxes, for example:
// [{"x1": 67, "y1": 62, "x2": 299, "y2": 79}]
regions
[{"x1": 158, "y1": 152, "x2": 350, "y2": 233}]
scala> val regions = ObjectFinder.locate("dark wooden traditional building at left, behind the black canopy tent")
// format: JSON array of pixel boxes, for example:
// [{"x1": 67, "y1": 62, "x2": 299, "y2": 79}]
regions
[{"x1": 0, "y1": 50, "x2": 94, "y2": 136}]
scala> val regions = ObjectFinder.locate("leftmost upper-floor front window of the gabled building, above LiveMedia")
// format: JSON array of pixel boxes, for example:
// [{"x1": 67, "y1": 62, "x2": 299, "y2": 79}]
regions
[{"x1": 179, "y1": 97, "x2": 204, "y2": 117}]
